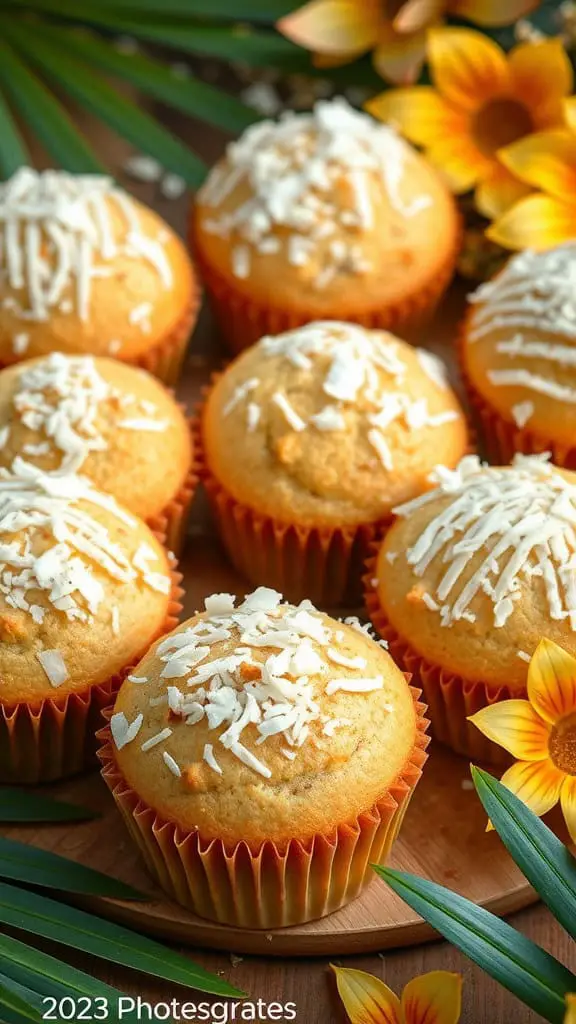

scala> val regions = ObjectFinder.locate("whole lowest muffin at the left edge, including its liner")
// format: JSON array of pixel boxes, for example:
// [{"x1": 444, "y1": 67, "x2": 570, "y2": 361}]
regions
[{"x1": 0, "y1": 474, "x2": 179, "y2": 782}]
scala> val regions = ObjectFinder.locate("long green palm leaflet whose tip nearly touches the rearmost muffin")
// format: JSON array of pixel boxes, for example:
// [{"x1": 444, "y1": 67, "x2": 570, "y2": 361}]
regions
[{"x1": 1, "y1": 17, "x2": 206, "y2": 186}]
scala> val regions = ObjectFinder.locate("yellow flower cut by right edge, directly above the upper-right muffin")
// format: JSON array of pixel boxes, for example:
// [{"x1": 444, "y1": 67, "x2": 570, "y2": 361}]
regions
[{"x1": 487, "y1": 109, "x2": 576, "y2": 249}]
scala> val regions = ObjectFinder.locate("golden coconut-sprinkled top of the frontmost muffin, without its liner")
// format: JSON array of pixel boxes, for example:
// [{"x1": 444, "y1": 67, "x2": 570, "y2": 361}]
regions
[{"x1": 111, "y1": 587, "x2": 416, "y2": 844}]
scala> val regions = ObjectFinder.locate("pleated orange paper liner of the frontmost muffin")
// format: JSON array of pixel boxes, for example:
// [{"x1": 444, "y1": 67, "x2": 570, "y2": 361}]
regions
[{"x1": 98, "y1": 687, "x2": 428, "y2": 929}]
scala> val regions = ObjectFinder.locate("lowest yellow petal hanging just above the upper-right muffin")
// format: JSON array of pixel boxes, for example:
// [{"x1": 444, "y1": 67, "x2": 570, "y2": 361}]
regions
[{"x1": 486, "y1": 193, "x2": 576, "y2": 250}]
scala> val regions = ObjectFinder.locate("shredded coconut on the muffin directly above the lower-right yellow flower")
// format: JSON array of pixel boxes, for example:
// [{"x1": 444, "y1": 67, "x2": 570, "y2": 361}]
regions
[{"x1": 395, "y1": 455, "x2": 576, "y2": 630}]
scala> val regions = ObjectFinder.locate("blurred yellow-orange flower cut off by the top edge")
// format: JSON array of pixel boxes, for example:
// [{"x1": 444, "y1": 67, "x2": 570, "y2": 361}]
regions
[{"x1": 277, "y1": 0, "x2": 540, "y2": 83}]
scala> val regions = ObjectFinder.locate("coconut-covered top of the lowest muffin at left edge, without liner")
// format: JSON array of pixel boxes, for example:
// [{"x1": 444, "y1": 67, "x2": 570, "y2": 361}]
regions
[{"x1": 0, "y1": 473, "x2": 171, "y2": 706}]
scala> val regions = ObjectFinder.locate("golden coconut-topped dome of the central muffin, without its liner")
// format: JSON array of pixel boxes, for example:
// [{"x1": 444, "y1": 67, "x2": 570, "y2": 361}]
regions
[{"x1": 203, "y1": 323, "x2": 467, "y2": 525}]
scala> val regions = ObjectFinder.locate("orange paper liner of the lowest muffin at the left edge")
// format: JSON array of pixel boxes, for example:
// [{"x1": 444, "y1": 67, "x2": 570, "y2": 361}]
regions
[{"x1": 0, "y1": 559, "x2": 182, "y2": 784}]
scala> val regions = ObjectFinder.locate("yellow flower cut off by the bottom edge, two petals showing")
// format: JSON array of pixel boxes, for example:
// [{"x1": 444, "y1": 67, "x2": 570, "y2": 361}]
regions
[{"x1": 332, "y1": 966, "x2": 462, "y2": 1024}]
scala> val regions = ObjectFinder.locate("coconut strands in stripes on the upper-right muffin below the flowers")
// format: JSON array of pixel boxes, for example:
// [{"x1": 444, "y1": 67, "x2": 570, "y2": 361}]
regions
[{"x1": 467, "y1": 242, "x2": 576, "y2": 407}]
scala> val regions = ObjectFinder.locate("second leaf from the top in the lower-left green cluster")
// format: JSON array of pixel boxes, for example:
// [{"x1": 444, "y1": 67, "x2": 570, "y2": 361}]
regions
[{"x1": 0, "y1": 837, "x2": 147, "y2": 900}]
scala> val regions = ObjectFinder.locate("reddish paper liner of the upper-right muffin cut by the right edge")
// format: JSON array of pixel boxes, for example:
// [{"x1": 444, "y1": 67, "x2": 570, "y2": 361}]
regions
[{"x1": 458, "y1": 316, "x2": 576, "y2": 469}]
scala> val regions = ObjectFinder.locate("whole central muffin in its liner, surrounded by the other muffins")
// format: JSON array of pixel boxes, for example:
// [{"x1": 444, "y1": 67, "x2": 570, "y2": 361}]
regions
[{"x1": 199, "y1": 322, "x2": 467, "y2": 606}]
